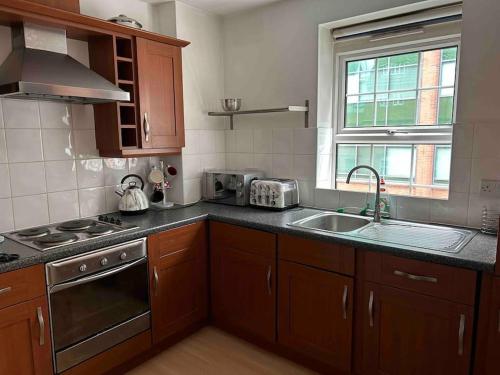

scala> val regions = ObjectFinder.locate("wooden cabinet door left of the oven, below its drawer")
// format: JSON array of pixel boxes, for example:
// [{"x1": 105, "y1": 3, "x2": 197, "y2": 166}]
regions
[{"x1": 0, "y1": 297, "x2": 52, "y2": 375}]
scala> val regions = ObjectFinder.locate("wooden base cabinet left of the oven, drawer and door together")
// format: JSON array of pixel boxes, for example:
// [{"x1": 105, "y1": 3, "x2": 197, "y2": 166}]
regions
[{"x1": 0, "y1": 265, "x2": 53, "y2": 375}]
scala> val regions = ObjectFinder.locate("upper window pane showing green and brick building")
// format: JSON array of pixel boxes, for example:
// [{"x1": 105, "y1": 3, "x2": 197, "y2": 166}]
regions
[{"x1": 344, "y1": 47, "x2": 458, "y2": 127}]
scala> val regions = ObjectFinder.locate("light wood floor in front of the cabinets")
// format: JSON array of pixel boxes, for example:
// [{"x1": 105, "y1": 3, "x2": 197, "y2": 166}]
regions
[{"x1": 127, "y1": 327, "x2": 316, "y2": 375}]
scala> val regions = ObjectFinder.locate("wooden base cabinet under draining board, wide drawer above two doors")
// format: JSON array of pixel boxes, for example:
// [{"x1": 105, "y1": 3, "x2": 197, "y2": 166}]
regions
[{"x1": 355, "y1": 251, "x2": 476, "y2": 375}]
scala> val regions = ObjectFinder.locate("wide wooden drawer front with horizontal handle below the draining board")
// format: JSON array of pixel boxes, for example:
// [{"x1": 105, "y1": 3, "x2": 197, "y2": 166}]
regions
[{"x1": 358, "y1": 251, "x2": 477, "y2": 305}]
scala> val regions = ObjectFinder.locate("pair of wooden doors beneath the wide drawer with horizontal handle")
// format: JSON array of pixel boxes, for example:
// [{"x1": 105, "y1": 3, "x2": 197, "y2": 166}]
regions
[{"x1": 359, "y1": 283, "x2": 473, "y2": 375}]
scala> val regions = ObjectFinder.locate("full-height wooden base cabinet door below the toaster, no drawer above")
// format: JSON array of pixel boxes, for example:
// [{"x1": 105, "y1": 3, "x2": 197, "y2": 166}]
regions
[{"x1": 210, "y1": 222, "x2": 276, "y2": 343}]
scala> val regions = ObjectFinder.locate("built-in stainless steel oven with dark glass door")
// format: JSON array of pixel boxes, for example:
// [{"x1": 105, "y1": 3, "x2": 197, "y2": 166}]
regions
[{"x1": 46, "y1": 238, "x2": 151, "y2": 373}]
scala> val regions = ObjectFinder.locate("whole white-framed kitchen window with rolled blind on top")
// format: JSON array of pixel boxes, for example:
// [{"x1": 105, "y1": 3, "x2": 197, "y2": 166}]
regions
[{"x1": 326, "y1": 2, "x2": 461, "y2": 199}]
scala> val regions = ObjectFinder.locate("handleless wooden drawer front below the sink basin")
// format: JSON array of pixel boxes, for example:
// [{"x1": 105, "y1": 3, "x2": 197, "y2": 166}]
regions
[{"x1": 278, "y1": 234, "x2": 355, "y2": 275}]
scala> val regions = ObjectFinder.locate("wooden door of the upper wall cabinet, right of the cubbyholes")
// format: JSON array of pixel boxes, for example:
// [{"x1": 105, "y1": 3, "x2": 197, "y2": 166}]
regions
[{"x1": 137, "y1": 38, "x2": 184, "y2": 149}]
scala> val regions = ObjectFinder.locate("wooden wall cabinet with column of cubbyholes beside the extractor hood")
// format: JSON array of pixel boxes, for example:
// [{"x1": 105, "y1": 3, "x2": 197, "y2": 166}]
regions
[{"x1": 89, "y1": 35, "x2": 184, "y2": 157}]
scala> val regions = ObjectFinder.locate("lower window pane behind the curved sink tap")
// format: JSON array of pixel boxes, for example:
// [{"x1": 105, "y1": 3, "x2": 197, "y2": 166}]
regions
[{"x1": 336, "y1": 144, "x2": 451, "y2": 199}]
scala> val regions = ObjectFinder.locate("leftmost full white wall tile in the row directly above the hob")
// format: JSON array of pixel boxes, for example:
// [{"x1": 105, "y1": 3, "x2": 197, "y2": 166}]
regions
[{"x1": 12, "y1": 194, "x2": 49, "y2": 229}]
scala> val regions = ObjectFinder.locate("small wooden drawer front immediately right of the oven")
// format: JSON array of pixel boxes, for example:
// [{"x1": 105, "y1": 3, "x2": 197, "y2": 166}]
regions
[{"x1": 148, "y1": 222, "x2": 207, "y2": 263}]
